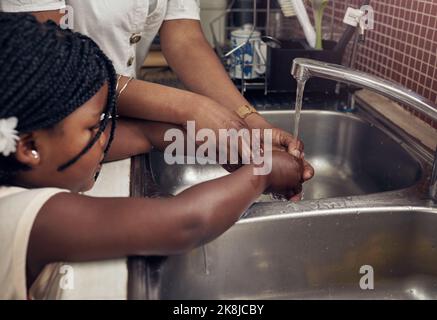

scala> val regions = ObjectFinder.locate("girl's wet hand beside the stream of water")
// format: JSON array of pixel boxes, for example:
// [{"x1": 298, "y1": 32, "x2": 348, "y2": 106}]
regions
[{"x1": 267, "y1": 151, "x2": 305, "y2": 199}]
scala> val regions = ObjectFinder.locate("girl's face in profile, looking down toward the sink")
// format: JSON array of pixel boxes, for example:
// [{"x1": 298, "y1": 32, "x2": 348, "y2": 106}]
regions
[{"x1": 18, "y1": 84, "x2": 111, "y2": 192}]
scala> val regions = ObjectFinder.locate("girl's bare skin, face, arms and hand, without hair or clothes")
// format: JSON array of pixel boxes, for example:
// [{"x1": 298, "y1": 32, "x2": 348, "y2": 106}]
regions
[{"x1": 15, "y1": 85, "x2": 303, "y2": 284}]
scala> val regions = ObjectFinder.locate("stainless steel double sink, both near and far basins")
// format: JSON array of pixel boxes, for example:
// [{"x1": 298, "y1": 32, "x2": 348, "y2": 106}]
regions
[{"x1": 139, "y1": 111, "x2": 437, "y2": 300}]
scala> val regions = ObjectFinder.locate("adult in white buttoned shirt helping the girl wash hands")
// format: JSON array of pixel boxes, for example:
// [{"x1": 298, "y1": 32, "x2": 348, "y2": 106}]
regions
[{"x1": 0, "y1": 0, "x2": 314, "y2": 172}]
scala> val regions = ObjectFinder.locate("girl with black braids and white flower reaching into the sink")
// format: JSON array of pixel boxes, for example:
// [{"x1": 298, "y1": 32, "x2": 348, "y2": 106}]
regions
[{"x1": 0, "y1": 13, "x2": 303, "y2": 299}]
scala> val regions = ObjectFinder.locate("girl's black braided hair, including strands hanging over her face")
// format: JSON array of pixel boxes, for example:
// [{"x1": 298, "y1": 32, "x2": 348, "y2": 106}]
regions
[{"x1": 0, "y1": 13, "x2": 117, "y2": 185}]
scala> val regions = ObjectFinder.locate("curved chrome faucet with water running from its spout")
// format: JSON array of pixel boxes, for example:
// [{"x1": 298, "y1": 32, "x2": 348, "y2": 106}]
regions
[{"x1": 291, "y1": 58, "x2": 437, "y2": 202}]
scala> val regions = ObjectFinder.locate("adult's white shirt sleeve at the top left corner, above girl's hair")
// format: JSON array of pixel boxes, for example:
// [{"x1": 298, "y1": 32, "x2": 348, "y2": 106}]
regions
[{"x1": 0, "y1": 0, "x2": 65, "y2": 12}]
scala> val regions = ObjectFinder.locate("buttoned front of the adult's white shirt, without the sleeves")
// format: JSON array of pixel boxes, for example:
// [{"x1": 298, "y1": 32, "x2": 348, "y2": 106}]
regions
[{"x1": 66, "y1": 0, "x2": 168, "y2": 76}]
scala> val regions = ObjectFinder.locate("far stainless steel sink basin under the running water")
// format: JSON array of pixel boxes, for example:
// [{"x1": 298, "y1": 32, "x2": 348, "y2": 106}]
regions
[{"x1": 149, "y1": 111, "x2": 422, "y2": 201}]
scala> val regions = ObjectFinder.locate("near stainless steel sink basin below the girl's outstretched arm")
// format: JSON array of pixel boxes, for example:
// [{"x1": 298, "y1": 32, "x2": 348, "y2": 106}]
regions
[{"x1": 148, "y1": 207, "x2": 437, "y2": 300}]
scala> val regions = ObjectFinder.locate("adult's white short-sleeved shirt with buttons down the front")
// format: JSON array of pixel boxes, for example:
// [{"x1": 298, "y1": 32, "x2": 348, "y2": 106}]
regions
[{"x1": 0, "y1": 0, "x2": 200, "y2": 77}]
